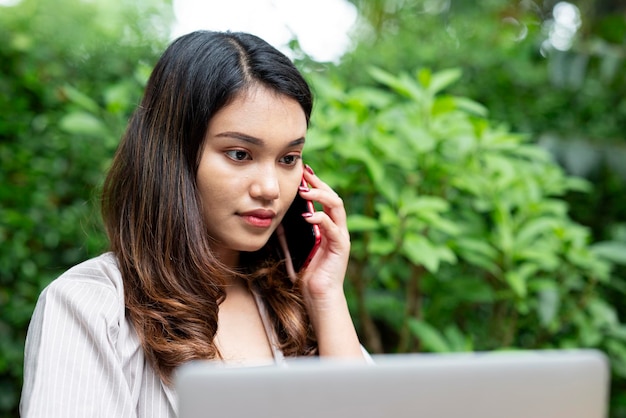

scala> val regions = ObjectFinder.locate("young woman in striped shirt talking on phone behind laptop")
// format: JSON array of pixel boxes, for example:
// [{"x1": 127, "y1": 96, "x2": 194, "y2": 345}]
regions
[{"x1": 20, "y1": 31, "x2": 363, "y2": 417}]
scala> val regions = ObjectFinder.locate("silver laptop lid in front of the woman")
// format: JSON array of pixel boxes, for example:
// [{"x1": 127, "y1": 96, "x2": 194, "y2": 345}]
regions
[{"x1": 175, "y1": 350, "x2": 609, "y2": 418}]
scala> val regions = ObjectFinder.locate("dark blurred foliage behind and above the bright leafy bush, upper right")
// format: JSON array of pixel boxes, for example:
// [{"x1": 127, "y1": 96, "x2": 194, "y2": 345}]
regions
[{"x1": 326, "y1": 0, "x2": 626, "y2": 417}]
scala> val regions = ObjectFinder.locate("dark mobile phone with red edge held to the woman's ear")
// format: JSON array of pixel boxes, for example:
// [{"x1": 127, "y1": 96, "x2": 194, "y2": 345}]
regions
[{"x1": 282, "y1": 177, "x2": 322, "y2": 272}]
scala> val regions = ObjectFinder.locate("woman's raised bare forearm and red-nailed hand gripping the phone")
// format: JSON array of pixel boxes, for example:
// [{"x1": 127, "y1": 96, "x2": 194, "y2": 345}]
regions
[{"x1": 300, "y1": 169, "x2": 364, "y2": 358}]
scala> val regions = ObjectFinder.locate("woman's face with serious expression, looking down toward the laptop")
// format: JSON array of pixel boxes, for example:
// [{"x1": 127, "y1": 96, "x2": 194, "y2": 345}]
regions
[{"x1": 197, "y1": 86, "x2": 307, "y2": 263}]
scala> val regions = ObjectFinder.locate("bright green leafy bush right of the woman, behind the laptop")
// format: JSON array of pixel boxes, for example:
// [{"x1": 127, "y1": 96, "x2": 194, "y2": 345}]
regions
[{"x1": 305, "y1": 69, "x2": 626, "y2": 412}]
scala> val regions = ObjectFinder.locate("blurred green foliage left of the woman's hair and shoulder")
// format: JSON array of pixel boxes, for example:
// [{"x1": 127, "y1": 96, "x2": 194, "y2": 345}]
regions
[{"x1": 0, "y1": 0, "x2": 171, "y2": 416}]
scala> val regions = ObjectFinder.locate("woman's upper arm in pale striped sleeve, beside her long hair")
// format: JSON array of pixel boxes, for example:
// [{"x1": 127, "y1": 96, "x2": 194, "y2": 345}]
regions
[{"x1": 20, "y1": 273, "x2": 135, "y2": 417}]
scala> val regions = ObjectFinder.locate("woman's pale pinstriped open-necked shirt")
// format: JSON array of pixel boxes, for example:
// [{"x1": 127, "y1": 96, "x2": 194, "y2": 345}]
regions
[{"x1": 20, "y1": 253, "x2": 283, "y2": 418}]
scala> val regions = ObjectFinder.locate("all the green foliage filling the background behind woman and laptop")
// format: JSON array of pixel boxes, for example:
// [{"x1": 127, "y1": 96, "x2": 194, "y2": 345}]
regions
[{"x1": 0, "y1": 0, "x2": 626, "y2": 417}]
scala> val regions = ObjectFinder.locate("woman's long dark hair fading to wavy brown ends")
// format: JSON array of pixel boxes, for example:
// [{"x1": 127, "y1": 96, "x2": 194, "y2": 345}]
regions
[{"x1": 102, "y1": 31, "x2": 315, "y2": 383}]
